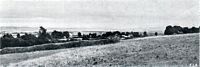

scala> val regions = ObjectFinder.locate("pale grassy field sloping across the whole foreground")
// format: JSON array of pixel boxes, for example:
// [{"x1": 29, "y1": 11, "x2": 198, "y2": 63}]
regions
[{"x1": 0, "y1": 34, "x2": 199, "y2": 67}]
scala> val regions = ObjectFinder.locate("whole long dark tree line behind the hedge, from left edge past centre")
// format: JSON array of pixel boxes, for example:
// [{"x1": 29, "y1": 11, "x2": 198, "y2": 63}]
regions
[{"x1": 0, "y1": 26, "x2": 153, "y2": 48}]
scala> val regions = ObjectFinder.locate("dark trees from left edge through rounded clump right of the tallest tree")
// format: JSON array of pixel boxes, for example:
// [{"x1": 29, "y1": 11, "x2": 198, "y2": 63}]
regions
[{"x1": 0, "y1": 27, "x2": 69, "y2": 48}]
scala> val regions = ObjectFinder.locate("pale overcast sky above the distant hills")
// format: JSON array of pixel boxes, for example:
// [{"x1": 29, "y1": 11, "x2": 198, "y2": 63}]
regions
[{"x1": 0, "y1": 0, "x2": 199, "y2": 29}]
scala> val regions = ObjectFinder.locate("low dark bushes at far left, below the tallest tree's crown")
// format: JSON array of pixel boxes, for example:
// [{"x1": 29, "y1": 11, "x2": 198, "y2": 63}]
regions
[{"x1": 1, "y1": 35, "x2": 50, "y2": 48}]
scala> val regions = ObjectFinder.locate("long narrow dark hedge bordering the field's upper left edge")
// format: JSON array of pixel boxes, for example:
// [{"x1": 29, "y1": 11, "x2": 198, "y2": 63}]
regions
[{"x1": 0, "y1": 39, "x2": 120, "y2": 54}]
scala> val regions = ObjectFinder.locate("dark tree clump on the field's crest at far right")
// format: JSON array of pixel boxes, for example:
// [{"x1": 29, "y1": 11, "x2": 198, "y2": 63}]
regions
[{"x1": 164, "y1": 26, "x2": 199, "y2": 35}]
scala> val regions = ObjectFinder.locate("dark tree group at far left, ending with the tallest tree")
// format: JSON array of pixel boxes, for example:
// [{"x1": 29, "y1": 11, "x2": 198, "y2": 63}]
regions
[{"x1": 0, "y1": 27, "x2": 51, "y2": 48}]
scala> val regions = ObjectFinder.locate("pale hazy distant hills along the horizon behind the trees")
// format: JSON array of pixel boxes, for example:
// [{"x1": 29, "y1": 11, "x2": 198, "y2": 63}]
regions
[{"x1": 0, "y1": 26, "x2": 164, "y2": 33}]
